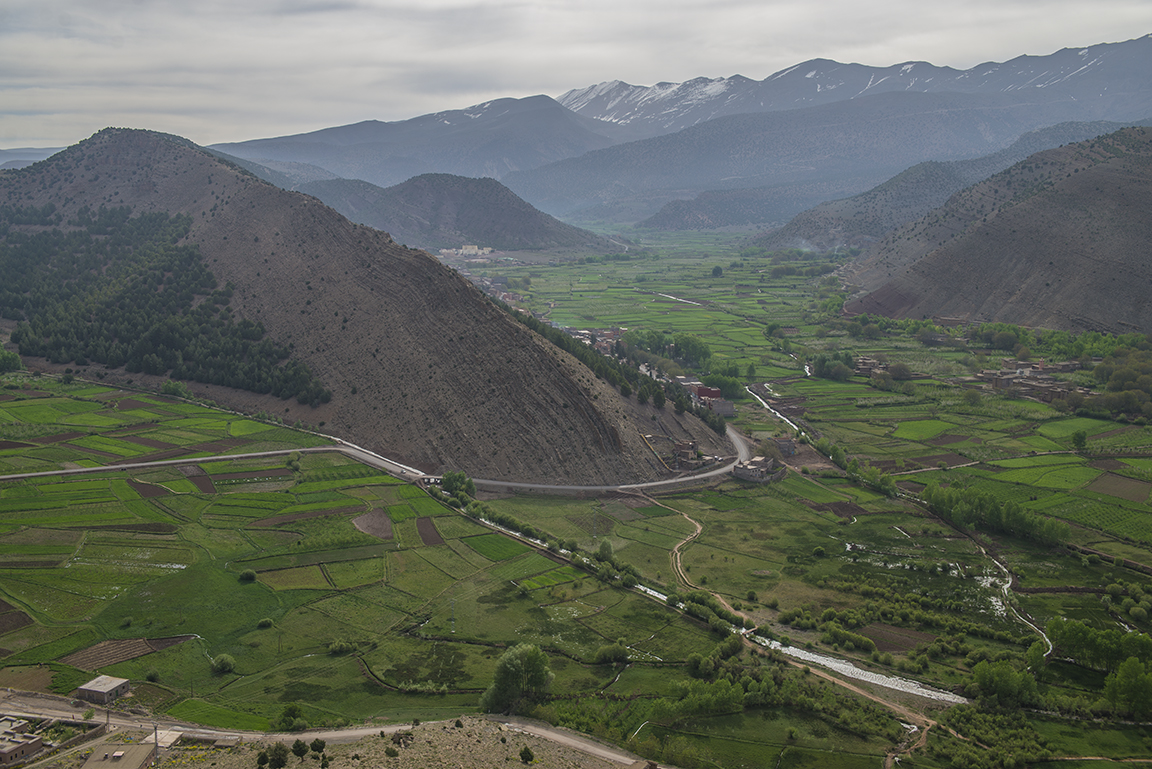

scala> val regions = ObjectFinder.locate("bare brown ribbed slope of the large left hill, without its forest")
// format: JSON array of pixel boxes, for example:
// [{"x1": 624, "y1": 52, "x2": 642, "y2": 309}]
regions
[{"x1": 0, "y1": 129, "x2": 720, "y2": 484}]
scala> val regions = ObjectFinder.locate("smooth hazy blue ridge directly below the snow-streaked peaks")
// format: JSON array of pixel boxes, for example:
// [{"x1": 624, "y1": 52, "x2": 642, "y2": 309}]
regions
[{"x1": 502, "y1": 93, "x2": 1115, "y2": 222}]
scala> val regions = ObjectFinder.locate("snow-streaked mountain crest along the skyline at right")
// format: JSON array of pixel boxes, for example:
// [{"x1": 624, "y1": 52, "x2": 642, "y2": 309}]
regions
[{"x1": 556, "y1": 35, "x2": 1152, "y2": 137}]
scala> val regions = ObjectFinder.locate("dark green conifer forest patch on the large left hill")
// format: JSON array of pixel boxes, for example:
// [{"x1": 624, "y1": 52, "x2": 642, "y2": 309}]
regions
[{"x1": 0, "y1": 206, "x2": 332, "y2": 405}]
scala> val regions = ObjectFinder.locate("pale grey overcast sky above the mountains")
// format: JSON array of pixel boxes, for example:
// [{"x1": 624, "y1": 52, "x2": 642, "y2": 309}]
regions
[{"x1": 0, "y1": 0, "x2": 1152, "y2": 150}]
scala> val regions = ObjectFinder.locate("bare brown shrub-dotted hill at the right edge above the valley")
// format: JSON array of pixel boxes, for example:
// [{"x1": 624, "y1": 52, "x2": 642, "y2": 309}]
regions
[{"x1": 843, "y1": 128, "x2": 1152, "y2": 333}]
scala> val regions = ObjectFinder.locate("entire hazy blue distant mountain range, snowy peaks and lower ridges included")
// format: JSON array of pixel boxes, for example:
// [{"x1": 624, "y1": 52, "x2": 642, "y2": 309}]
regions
[{"x1": 9, "y1": 35, "x2": 1152, "y2": 228}]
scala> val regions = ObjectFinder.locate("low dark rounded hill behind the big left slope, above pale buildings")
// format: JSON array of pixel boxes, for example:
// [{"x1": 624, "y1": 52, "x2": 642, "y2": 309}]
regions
[{"x1": 297, "y1": 174, "x2": 620, "y2": 251}]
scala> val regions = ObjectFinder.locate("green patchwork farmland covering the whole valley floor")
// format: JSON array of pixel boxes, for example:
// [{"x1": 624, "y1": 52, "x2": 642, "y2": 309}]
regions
[{"x1": 0, "y1": 230, "x2": 1152, "y2": 768}]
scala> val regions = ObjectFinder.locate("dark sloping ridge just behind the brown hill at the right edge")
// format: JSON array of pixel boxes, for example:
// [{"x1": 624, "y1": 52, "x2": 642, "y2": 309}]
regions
[{"x1": 755, "y1": 122, "x2": 1146, "y2": 251}]
